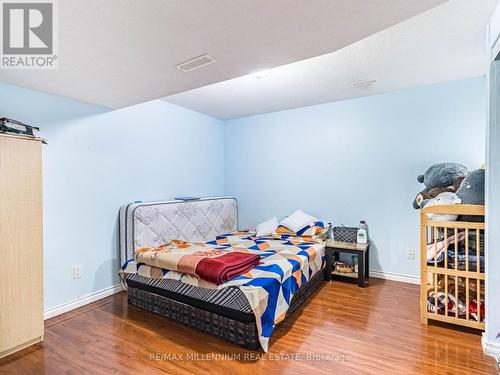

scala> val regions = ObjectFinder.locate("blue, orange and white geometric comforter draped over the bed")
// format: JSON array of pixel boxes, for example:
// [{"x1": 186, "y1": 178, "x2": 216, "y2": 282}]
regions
[{"x1": 120, "y1": 232, "x2": 325, "y2": 352}]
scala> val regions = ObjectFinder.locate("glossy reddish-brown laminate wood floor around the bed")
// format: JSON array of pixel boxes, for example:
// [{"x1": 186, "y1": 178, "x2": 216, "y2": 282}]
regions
[{"x1": 0, "y1": 278, "x2": 497, "y2": 375}]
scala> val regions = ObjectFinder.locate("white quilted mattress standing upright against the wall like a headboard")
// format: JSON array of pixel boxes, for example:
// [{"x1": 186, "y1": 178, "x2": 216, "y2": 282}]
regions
[{"x1": 120, "y1": 197, "x2": 238, "y2": 264}]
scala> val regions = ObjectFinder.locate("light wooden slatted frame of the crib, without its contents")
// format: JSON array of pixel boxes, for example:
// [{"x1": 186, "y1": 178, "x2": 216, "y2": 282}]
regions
[{"x1": 420, "y1": 204, "x2": 485, "y2": 330}]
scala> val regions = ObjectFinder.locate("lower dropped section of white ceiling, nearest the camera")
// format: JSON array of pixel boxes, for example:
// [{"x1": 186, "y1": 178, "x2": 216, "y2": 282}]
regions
[{"x1": 0, "y1": 0, "x2": 446, "y2": 109}]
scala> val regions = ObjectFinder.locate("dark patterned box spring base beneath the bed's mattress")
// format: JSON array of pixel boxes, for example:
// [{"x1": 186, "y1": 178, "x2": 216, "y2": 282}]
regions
[{"x1": 128, "y1": 268, "x2": 325, "y2": 350}]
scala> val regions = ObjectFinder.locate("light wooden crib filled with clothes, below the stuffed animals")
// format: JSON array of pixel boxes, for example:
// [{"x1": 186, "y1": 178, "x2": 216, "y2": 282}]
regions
[{"x1": 420, "y1": 204, "x2": 485, "y2": 330}]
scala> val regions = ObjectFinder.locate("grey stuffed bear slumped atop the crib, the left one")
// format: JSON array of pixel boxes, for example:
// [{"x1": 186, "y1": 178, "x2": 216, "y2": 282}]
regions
[{"x1": 413, "y1": 163, "x2": 468, "y2": 209}]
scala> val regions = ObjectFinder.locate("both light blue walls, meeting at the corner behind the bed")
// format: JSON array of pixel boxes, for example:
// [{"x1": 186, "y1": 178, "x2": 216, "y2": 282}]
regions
[{"x1": 0, "y1": 78, "x2": 486, "y2": 309}]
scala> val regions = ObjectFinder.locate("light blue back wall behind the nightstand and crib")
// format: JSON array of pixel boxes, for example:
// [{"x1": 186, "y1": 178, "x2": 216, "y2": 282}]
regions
[{"x1": 225, "y1": 78, "x2": 486, "y2": 277}]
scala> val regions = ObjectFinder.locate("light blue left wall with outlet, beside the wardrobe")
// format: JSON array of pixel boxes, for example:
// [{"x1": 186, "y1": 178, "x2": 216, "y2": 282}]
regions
[{"x1": 0, "y1": 84, "x2": 224, "y2": 309}]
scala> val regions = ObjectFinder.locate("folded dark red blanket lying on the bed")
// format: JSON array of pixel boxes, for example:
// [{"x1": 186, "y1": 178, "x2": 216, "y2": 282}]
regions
[{"x1": 196, "y1": 252, "x2": 260, "y2": 285}]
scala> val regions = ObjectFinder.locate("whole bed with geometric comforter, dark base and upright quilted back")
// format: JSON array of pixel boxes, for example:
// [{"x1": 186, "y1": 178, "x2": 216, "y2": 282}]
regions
[{"x1": 120, "y1": 197, "x2": 324, "y2": 351}]
